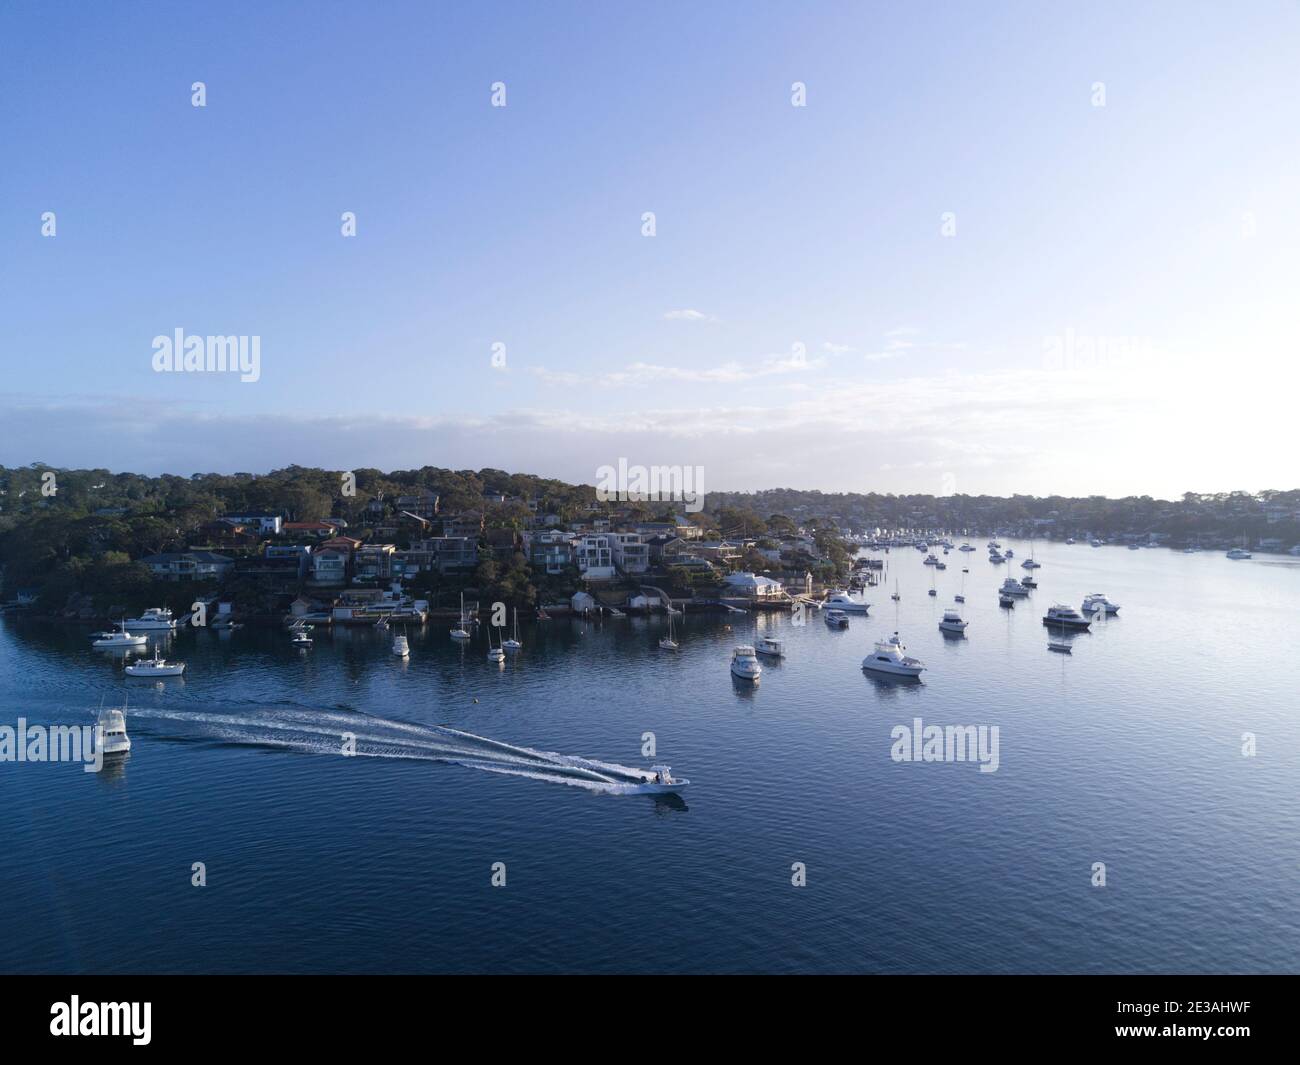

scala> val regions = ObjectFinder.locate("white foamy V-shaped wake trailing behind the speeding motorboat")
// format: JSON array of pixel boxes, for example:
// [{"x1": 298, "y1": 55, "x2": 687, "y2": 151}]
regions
[{"x1": 111, "y1": 707, "x2": 654, "y2": 795}]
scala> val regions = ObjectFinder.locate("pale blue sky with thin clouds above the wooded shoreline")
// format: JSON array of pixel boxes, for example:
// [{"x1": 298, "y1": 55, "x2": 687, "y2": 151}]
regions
[{"x1": 0, "y1": 3, "x2": 1300, "y2": 495}]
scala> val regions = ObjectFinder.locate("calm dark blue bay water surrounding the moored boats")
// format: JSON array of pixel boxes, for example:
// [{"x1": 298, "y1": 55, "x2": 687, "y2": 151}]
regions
[{"x1": 0, "y1": 541, "x2": 1300, "y2": 973}]
